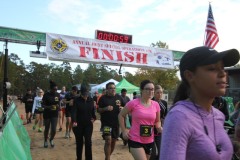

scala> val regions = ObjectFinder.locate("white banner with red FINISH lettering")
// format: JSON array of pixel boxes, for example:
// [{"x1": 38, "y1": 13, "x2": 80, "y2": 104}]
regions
[{"x1": 46, "y1": 33, "x2": 174, "y2": 69}]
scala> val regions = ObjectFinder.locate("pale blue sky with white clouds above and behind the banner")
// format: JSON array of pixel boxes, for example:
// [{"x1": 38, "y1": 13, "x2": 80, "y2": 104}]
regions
[{"x1": 0, "y1": 0, "x2": 240, "y2": 74}]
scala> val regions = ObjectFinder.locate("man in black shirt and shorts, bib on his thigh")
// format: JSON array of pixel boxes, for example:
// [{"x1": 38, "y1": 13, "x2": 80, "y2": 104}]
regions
[{"x1": 98, "y1": 82, "x2": 124, "y2": 160}]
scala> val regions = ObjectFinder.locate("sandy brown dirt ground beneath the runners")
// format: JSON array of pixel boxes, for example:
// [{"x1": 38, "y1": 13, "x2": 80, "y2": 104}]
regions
[{"x1": 7, "y1": 101, "x2": 133, "y2": 160}]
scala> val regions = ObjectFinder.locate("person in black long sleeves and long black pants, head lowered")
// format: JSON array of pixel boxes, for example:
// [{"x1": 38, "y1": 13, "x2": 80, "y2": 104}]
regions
[{"x1": 72, "y1": 86, "x2": 96, "y2": 160}]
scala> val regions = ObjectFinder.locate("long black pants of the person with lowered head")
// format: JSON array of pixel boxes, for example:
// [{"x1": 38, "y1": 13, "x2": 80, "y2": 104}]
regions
[{"x1": 73, "y1": 123, "x2": 93, "y2": 160}]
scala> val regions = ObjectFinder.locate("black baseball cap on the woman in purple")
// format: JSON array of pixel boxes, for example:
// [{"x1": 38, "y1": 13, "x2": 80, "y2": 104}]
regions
[{"x1": 179, "y1": 46, "x2": 239, "y2": 78}]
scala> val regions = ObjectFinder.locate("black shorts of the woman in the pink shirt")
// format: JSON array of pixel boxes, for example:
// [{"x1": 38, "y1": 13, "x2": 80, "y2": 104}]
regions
[{"x1": 128, "y1": 139, "x2": 154, "y2": 155}]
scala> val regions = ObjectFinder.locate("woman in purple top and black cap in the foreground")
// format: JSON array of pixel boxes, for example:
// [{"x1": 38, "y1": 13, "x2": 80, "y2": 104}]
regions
[{"x1": 160, "y1": 47, "x2": 239, "y2": 160}]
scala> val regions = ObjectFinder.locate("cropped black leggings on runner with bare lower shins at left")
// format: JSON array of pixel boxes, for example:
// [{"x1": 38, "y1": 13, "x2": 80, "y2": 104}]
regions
[{"x1": 44, "y1": 117, "x2": 58, "y2": 141}]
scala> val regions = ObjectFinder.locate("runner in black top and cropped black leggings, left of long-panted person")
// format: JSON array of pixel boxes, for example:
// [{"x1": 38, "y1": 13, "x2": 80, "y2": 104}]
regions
[{"x1": 42, "y1": 81, "x2": 60, "y2": 148}]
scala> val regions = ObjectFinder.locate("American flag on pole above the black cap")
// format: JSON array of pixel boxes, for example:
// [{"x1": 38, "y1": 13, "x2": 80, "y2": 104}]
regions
[{"x1": 205, "y1": 4, "x2": 219, "y2": 48}]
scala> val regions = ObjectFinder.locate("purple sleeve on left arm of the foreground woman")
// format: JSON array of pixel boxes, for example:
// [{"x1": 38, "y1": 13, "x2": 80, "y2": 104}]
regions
[{"x1": 160, "y1": 110, "x2": 190, "y2": 160}]
